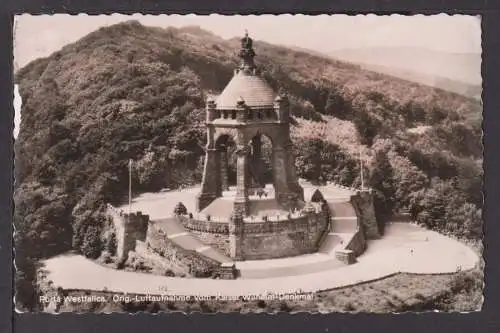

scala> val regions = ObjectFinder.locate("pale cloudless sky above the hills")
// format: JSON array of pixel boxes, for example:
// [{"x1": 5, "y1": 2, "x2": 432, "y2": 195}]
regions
[{"x1": 14, "y1": 14, "x2": 481, "y2": 133}]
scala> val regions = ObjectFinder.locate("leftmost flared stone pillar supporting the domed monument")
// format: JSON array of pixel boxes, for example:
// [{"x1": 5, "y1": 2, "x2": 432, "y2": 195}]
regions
[{"x1": 196, "y1": 146, "x2": 222, "y2": 211}]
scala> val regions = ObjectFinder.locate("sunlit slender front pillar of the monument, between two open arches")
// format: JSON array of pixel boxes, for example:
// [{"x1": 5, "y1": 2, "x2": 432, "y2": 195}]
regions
[{"x1": 234, "y1": 144, "x2": 249, "y2": 216}]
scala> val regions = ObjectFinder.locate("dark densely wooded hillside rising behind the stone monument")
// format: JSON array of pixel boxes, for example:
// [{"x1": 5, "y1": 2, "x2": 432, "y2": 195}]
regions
[{"x1": 15, "y1": 22, "x2": 482, "y2": 306}]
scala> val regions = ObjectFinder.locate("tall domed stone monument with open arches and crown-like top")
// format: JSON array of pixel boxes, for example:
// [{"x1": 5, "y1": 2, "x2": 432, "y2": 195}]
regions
[{"x1": 197, "y1": 34, "x2": 304, "y2": 216}]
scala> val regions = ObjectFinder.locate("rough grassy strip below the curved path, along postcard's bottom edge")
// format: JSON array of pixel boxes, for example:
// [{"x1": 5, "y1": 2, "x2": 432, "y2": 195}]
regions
[{"x1": 48, "y1": 270, "x2": 483, "y2": 313}]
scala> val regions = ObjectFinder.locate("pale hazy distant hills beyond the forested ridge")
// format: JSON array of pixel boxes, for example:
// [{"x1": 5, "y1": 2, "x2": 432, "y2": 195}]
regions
[{"x1": 330, "y1": 47, "x2": 482, "y2": 99}]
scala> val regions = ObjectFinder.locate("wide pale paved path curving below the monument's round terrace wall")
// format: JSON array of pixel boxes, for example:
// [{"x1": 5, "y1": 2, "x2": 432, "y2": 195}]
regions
[{"x1": 44, "y1": 223, "x2": 479, "y2": 297}]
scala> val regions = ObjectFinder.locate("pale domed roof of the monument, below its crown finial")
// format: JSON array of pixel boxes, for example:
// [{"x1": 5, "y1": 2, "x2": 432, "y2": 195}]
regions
[{"x1": 216, "y1": 70, "x2": 276, "y2": 109}]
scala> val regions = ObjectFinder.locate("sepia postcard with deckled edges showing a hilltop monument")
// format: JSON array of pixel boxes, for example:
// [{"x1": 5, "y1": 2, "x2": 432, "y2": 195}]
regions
[{"x1": 13, "y1": 14, "x2": 484, "y2": 314}]
